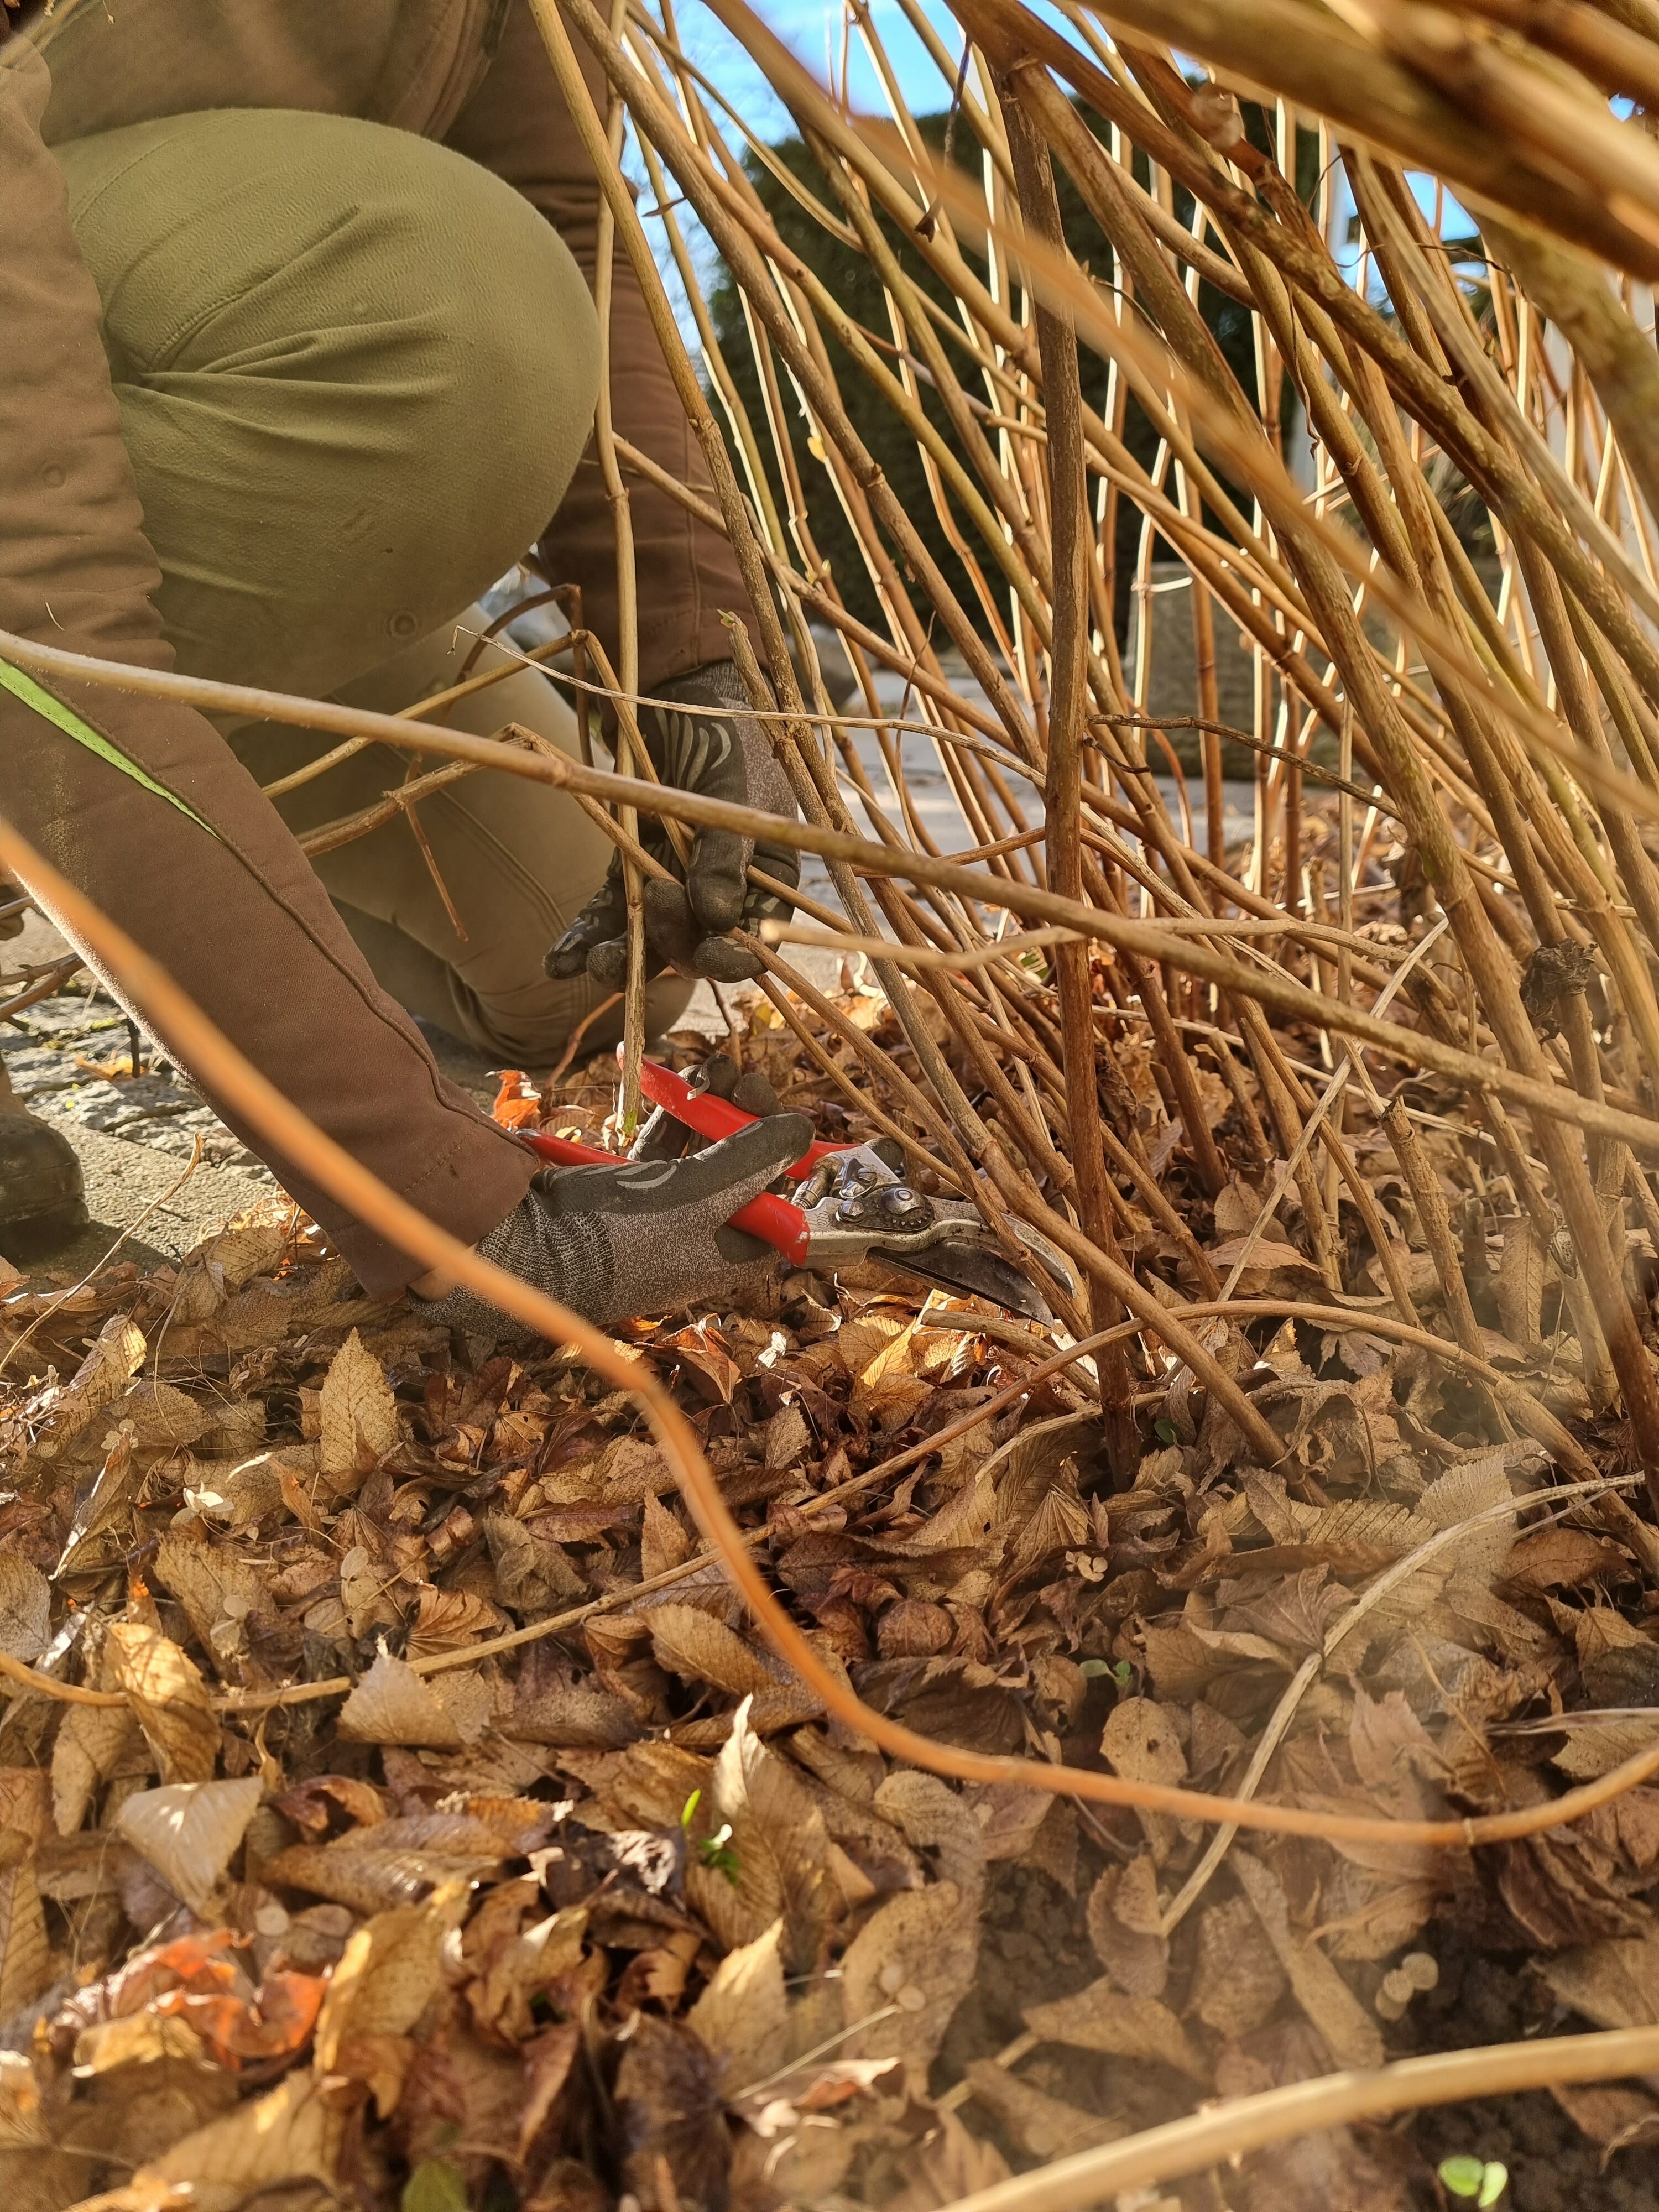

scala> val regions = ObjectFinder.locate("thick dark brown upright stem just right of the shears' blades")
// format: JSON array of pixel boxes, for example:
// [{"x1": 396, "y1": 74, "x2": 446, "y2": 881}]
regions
[{"x1": 1002, "y1": 86, "x2": 1139, "y2": 1480}]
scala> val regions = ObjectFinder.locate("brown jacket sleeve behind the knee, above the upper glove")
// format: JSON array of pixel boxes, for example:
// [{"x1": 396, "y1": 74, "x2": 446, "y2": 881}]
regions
[{"x1": 447, "y1": 0, "x2": 748, "y2": 690}]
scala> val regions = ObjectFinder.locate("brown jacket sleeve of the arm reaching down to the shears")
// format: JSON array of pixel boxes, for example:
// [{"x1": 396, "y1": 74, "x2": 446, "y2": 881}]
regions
[{"x1": 0, "y1": 40, "x2": 535, "y2": 1294}]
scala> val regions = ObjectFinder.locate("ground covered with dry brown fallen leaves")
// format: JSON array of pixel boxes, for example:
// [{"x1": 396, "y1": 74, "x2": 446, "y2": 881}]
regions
[{"x1": 0, "y1": 991, "x2": 1659, "y2": 2212}]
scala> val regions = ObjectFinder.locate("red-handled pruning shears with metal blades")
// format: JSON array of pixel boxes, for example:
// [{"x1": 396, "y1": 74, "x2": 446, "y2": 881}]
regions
[{"x1": 518, "y1": 1060, "x2": 1075, "y2": 1325}]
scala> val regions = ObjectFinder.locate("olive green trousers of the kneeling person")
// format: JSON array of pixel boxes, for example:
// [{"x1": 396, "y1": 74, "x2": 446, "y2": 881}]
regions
[{"x1": 55, "y1": 108, "x2": 688, "y2": 1066}]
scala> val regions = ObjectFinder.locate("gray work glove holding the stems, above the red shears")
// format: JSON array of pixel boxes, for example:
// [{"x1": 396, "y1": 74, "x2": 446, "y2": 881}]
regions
[{"x1": 546, "y1": 661, "x2": 801, "y2": 991}]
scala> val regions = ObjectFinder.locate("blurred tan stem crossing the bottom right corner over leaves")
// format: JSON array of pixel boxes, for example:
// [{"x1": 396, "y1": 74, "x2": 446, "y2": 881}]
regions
[{"x1": 945, "y1": 2028, "x2": 1659, "y2": 2212}]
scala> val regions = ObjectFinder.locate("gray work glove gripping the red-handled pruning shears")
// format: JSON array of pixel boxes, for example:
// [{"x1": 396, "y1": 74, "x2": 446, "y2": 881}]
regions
[{"x1": 418, "y1": 1113, "x2": 814, "y2": 1343}]
